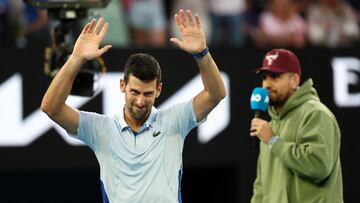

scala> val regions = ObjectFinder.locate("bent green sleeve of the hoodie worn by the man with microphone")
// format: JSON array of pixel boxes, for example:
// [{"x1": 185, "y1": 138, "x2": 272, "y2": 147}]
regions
[{"x1": 271, "y1": 111, "x2": 340, "y2": 182}]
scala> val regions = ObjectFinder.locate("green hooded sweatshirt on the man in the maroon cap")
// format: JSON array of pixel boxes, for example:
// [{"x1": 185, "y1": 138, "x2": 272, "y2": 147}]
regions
[{"x1": 251, "y1": 79, "x2": 343, "y2": 203}]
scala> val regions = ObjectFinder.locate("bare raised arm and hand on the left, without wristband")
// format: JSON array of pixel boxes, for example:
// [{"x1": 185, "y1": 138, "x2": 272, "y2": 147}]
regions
[{"x1": 41, "y1": 18, "x2": 111, "y2": 134}]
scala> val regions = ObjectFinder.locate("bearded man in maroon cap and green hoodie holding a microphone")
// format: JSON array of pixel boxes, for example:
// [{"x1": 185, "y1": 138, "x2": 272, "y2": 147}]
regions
[{"x1": 250, "y1": 49, "x2": 343, "y2": 203}]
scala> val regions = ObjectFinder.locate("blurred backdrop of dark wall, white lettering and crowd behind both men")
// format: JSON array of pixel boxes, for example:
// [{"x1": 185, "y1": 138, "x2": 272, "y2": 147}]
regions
[{"x1": 0, "y1": 0, "x2": 360, "y2": 203}]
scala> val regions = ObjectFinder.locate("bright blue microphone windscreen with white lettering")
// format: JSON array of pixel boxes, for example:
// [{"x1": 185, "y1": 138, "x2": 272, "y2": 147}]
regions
[{"x1": 250, "y1": 87, "x2": 269, "y2": 111}]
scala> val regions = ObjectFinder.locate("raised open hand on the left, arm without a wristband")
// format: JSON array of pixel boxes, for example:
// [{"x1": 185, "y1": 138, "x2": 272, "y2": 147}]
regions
[{"x1": 72, "y1": 18, "x2": 111, "y2": 60}]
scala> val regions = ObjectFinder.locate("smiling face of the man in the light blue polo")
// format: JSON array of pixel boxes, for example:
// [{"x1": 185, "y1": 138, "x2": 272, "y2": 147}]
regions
[{"x1": 120, "y1": 75, "x2": 162, "y2": 122}]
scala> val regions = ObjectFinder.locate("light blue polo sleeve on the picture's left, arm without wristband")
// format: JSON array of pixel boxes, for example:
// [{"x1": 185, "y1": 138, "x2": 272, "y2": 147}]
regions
[{"x1": 69, "y1": 111, "x2": 106, "y2": 151}]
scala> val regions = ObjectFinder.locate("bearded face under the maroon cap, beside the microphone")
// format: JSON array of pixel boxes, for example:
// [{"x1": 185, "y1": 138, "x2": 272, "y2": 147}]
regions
[{"x1": 261, "y1": 71, "x2": 299, "y2": 107}]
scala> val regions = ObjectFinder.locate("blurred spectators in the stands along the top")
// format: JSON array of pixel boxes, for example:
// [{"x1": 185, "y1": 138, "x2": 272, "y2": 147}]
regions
[{"x1": 0, "y1": 0, "x2": 360, "y2": 48}]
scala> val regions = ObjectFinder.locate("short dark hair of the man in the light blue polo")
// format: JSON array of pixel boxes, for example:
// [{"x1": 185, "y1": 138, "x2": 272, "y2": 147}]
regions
[{"x1": 124, "y1": 53, "x2": 161, "y2": 85}]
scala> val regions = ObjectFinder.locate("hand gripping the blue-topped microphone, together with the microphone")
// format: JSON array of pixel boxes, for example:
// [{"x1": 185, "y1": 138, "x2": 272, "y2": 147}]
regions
[{"x1": 250, "y1": 87, "x2": 273, "y2": 146}]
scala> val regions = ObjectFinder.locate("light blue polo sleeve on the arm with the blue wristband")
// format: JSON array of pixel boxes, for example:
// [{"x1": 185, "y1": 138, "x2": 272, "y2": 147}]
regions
[{"x1": 167, "y1": 99, "x2": 206, "y2": 139}]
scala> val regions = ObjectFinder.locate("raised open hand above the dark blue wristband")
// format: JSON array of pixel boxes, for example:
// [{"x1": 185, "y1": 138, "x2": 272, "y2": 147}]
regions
[{"x1": 170, "y1": 9, "x2": 206, "y2": 54}]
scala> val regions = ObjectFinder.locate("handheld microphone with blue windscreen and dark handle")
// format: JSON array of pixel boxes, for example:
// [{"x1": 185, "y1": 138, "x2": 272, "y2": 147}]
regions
[{"x1": 250, "y1": 87, "x2": 270, "y2": 151}]
